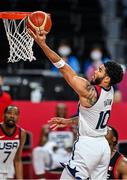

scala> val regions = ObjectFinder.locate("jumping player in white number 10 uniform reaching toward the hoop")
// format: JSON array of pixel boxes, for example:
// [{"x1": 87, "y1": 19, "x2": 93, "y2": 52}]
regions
[{"x1": 28, "y1": 30, "x2": 123, "y2": 180}]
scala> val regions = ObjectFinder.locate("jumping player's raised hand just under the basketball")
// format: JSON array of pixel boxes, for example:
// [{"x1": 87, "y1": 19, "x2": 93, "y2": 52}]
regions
[{"x1": 27, "y1": 29, "x2": 47, "y2": 47}]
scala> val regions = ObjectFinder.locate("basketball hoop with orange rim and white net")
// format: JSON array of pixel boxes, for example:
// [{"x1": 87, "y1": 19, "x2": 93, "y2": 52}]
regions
[{"x1": 0, "y1": 12, "x2": 36, "y2": 63}]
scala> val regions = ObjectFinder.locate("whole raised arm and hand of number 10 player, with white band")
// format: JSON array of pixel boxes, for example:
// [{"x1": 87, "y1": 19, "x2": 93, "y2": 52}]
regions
[{"x1": 29, "y1": 30, "x2": 96, "y2": 105}]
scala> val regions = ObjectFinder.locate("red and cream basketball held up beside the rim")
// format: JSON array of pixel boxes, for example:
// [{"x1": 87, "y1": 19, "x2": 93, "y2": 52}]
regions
[{"x1": 26, "y1": 11, "x2": 52, "y2": 32}]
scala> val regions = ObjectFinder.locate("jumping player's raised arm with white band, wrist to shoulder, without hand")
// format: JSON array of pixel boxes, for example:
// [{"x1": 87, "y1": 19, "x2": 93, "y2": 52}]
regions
[{"x1": 40, "y1": 43, "x2": 88, "y2": 96}]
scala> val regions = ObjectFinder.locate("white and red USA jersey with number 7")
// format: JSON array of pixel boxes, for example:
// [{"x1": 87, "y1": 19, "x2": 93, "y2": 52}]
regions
[{"x1": 0, "y1": 124, "x2": 21, "y2": 174}]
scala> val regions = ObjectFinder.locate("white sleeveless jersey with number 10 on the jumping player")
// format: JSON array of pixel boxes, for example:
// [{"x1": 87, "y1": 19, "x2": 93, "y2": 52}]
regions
[{"x1": 79, "y1": 86, "x2": 114, "y2": 137}]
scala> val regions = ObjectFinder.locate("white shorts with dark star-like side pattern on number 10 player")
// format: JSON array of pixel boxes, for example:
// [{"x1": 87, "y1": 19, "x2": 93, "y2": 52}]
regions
[{"x1": 66, "y1": 136, "x2": 111, "y2": 180}]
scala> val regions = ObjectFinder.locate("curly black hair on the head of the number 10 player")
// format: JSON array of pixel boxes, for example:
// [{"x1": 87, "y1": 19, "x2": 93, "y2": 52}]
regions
[{"x1": 104, "y1": 61, "x2": 123, "y2": 85}]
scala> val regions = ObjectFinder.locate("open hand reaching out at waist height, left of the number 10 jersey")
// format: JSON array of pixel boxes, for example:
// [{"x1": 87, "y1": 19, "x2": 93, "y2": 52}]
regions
[{"x1": 48, "y1": 117, "x2": 69, "y2": 130}]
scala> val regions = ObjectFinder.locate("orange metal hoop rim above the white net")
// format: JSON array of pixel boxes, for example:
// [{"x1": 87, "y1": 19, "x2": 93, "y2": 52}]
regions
[{"x1": 0, "y1": 11, "x2": 31, "y2": 20}]
